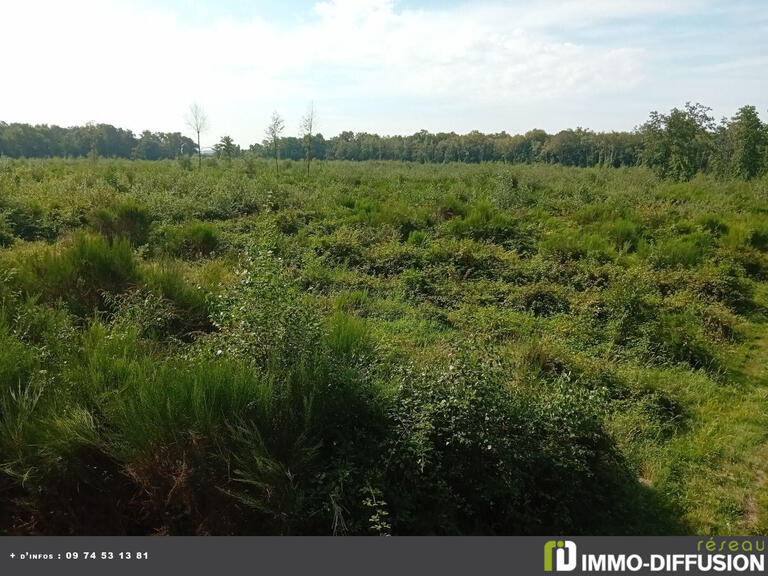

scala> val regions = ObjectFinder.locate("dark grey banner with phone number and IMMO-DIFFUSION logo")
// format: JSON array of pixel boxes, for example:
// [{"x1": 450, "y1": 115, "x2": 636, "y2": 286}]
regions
[{"x1": 0, "y1": 536, "x2": 766, "y2": 576}]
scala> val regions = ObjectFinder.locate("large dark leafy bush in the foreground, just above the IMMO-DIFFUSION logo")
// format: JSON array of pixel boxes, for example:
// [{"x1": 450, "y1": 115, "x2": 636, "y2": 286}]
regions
[{"x1": 383, "y1": 360, "x2": 632, "y2": 534}]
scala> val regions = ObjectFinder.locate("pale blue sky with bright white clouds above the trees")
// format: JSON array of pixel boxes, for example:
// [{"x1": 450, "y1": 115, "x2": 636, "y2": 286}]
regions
[{"x1": 0, "y1": 0, "x2": 768, "y2": 147}]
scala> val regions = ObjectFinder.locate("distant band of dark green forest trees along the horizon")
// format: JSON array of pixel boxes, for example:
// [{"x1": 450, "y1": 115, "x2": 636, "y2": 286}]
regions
[{"x1": 0, "y1": 103, "x2": 768, "y2": 180}]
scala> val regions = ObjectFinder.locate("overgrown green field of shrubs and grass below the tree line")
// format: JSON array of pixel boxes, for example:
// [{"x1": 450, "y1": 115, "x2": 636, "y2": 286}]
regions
[{"x1": 0, "y1": 158, "x2": 768, "y2": 535}]
